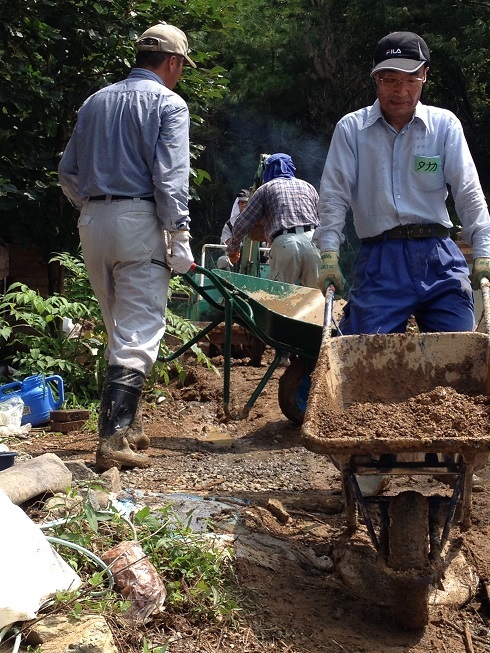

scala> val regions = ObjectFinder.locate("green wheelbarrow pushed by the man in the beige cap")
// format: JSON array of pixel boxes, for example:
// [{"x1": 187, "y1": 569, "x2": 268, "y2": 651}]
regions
[{"x1": 163, "y1": 265, "x2": 332, "y2": 423}]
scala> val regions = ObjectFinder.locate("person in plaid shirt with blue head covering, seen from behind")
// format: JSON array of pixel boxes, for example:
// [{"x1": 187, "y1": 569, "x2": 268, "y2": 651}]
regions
[{"x1": 228, "y1": 152, "x2": 321, "y2": 288}]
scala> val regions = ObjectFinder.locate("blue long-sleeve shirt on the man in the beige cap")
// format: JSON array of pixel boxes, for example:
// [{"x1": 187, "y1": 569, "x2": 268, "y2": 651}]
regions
[{"x1": 58, "y1": 68, "x2": 190, "y2": 231}]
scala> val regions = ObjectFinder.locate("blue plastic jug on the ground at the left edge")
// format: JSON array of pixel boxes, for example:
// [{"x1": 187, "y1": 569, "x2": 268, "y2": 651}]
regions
[{"x1": 0, "y1": 374, "x2": 65, "y2": 426}]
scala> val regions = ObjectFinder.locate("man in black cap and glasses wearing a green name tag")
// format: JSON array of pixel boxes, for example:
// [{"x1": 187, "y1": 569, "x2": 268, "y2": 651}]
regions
[{"x1": 314, "y1": 32, "x2": 490, "y2": 335}]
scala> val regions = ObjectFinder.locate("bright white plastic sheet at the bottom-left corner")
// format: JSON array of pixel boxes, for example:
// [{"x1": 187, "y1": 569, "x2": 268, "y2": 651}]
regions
[{"x1": 0, "y1": 490, "x2": 81, "y2": 629}]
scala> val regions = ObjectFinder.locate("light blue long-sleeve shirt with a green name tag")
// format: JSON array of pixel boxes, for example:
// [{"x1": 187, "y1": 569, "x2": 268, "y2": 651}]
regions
[{"x1": 314, "y1": 100, "x2": 490, "y2": 258}]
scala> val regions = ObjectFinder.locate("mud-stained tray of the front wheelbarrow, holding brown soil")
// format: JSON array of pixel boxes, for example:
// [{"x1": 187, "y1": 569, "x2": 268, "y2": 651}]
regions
[{"x1": 303, "y1": 332, "x2": 490, "y2": 457}]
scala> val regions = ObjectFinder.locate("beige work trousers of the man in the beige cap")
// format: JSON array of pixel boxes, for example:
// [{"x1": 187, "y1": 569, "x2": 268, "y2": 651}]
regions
[{"x1": 78, "y1": 199, "x2": 170, "y2": 376}]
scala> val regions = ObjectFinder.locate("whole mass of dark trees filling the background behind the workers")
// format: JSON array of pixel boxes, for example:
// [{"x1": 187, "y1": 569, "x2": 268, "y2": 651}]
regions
[{"x1": 0, "y1": 0, "x2": 490, "y2": 264}]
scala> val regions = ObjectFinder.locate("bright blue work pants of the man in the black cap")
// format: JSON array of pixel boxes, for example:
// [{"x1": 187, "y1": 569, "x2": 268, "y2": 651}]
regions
[{"x1": 339, "y1": 237, "x2": 475, "y2": 335}]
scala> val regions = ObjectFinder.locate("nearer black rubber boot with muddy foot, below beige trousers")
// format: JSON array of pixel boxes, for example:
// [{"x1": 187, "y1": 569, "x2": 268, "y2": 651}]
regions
[{"x1": 96, "y1": 365, "x2": 150, "y2": 469}]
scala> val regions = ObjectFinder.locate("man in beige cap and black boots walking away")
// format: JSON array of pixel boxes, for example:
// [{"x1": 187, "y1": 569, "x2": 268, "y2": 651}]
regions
[{"x1": 58, "y1": 23, "x2": 196, "y2": 469}]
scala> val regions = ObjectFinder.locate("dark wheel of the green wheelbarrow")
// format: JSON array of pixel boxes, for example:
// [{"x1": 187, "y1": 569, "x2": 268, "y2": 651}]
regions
[{"x1": 278, "y1": 355, "x2": 311, "y2": 424}]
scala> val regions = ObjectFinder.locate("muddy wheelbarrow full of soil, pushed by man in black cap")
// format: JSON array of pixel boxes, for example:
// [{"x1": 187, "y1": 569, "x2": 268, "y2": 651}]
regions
[{"x1": 302, "y1": 280, "x2": 490, "y2": 629}]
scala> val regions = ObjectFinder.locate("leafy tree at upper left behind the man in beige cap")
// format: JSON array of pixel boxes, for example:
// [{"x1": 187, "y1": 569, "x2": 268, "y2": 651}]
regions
[{"x1": 0, "y1": 0, "x2": 235, "y2": 259}]
